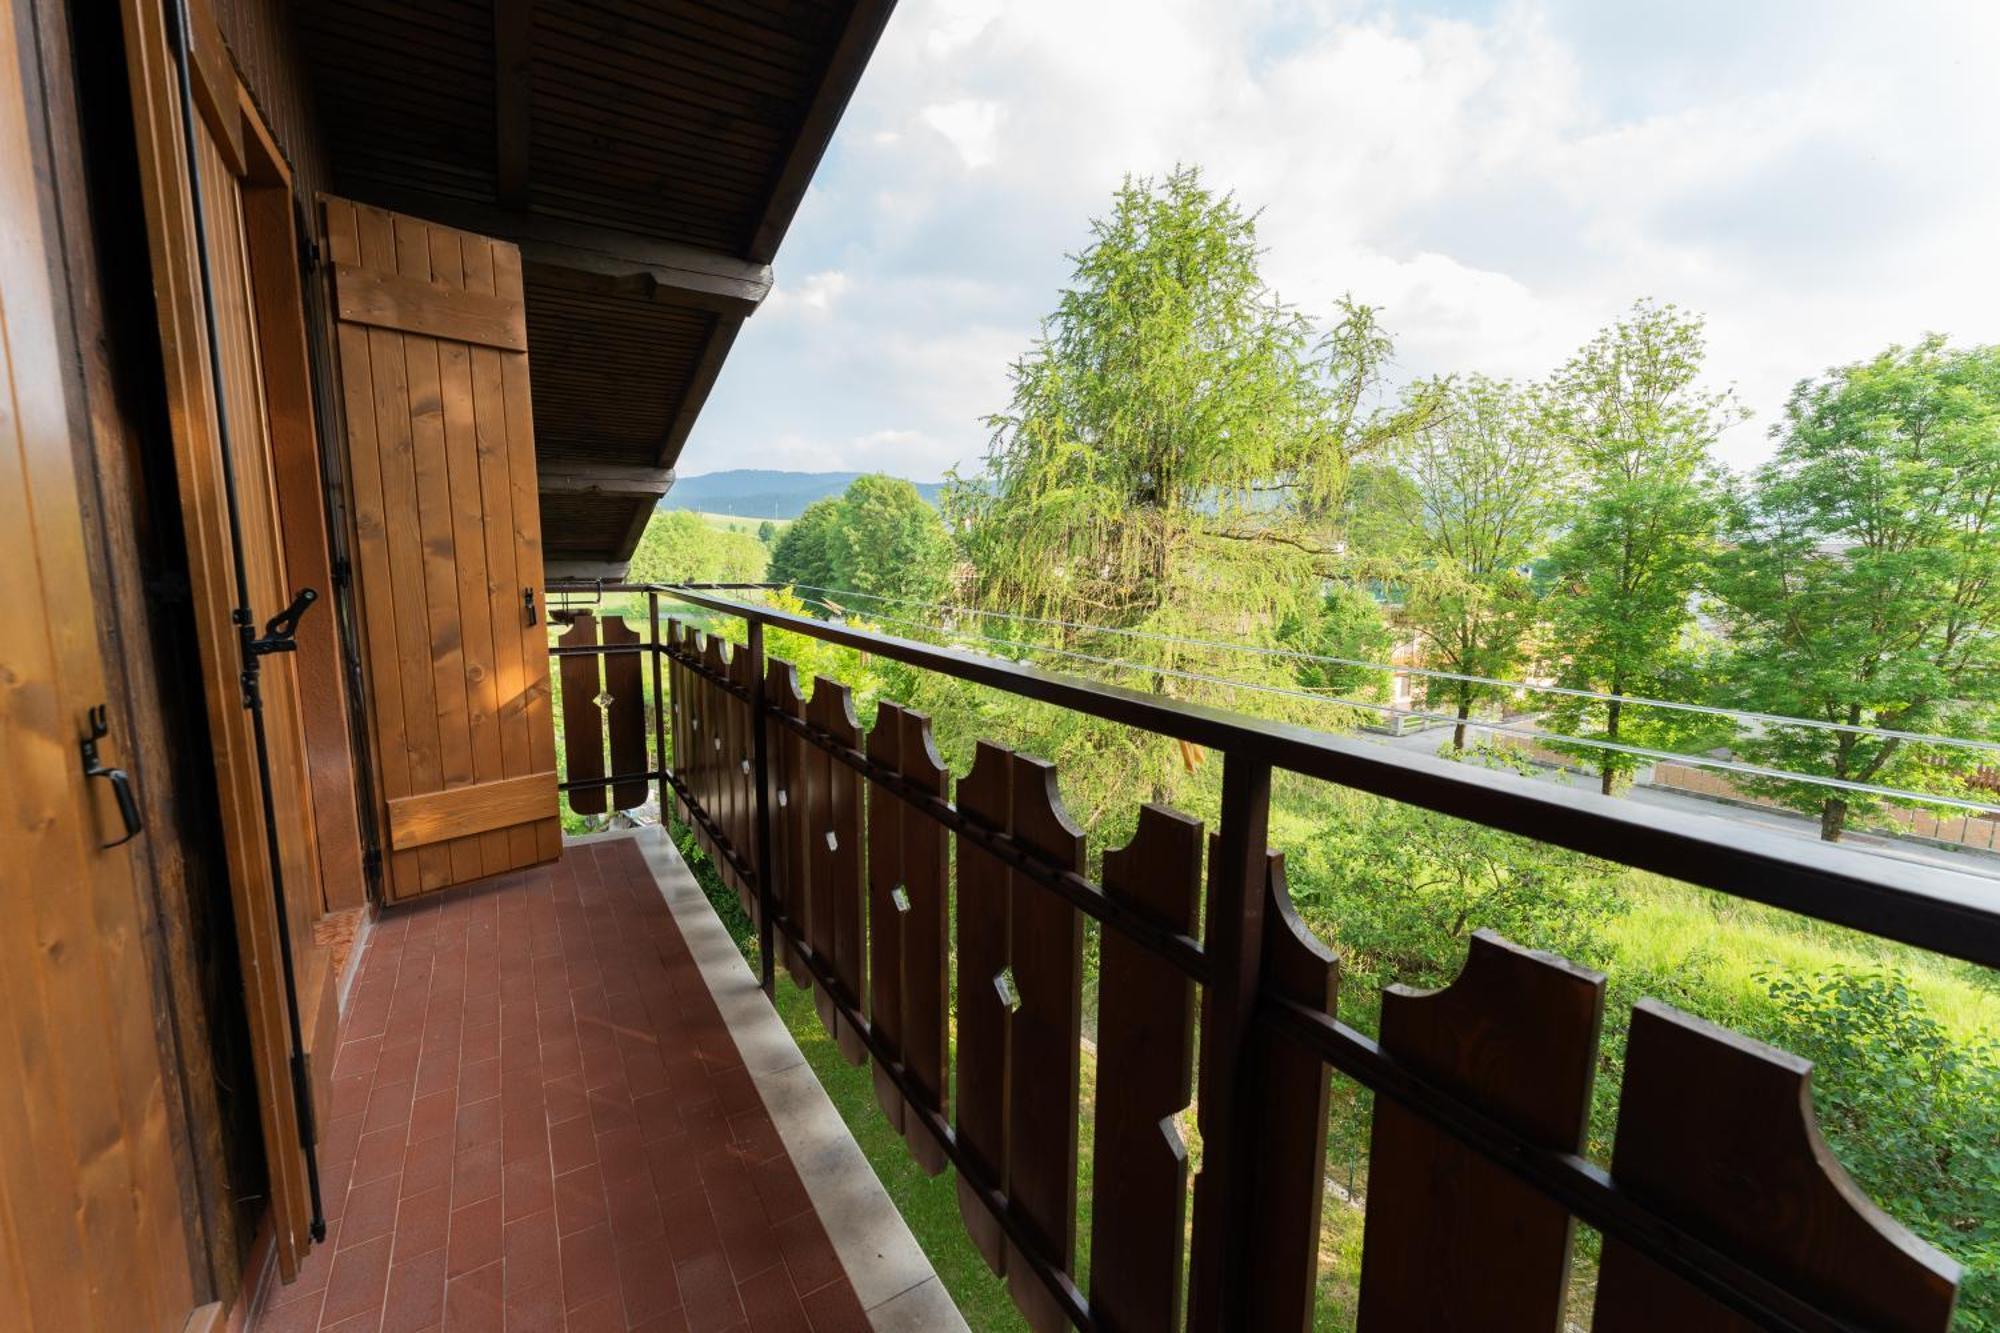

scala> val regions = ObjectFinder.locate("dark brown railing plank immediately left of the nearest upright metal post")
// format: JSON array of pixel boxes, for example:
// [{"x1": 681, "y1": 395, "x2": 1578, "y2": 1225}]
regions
[{"x1": 1090, "y1": 805, "x2": 1202, "y2": 1333}]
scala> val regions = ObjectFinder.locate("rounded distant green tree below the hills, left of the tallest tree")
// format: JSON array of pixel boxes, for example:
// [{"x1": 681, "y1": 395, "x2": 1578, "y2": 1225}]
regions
[{"x1": 770, "y1": 474, "x2": 952, "y2": 616}]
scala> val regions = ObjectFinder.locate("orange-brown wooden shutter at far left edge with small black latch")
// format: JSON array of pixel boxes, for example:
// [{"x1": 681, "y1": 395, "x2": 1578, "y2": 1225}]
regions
[{"x1": 0, "y1": 0, "x2": 194, "y2": 1333}]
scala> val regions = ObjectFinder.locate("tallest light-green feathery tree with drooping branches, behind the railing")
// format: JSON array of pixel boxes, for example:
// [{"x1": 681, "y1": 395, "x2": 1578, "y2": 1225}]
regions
[{"x1": 946, "y1": 170, "x2": 1420, "y2": 797}]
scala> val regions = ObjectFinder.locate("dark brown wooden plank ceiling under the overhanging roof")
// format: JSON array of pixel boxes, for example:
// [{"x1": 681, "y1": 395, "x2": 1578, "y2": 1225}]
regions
[{"x1": 298, "y1": 0, "x2": 894, "y2": 574}]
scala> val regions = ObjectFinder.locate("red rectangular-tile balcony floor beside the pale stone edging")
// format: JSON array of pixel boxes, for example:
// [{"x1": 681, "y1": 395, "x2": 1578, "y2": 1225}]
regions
[{"x1": 256, "y1": 841, "x2": 868, "y2": 1333}]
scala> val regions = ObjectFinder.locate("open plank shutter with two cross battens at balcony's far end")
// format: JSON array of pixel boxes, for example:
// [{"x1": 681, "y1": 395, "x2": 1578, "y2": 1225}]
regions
[{"x1": 322, "y1": 198, "x2": 562, "y2": 901}]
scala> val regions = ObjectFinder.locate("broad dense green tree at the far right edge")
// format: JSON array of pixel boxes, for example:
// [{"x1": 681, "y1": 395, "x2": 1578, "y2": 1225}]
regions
[{"x1": 1714, "y1": 336, "x2": 2000, "y2": 843}]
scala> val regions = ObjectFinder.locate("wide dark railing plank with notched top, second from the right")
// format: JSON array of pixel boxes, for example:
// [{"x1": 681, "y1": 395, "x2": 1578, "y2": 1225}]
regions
[{"x1": 1358, "y1": 931, "x2": 1604, "y2": 1333}]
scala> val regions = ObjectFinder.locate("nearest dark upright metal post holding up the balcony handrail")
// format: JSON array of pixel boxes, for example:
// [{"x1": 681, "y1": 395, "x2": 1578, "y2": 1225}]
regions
[{"x1": 1188, "y1": 751, "x2": 1270, "y2": 1333}]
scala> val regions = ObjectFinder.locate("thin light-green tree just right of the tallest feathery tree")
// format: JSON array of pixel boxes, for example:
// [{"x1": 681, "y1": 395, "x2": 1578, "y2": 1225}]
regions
[{"x1": 1402, "y1": 376, "x2": 1562, "y2": 751}]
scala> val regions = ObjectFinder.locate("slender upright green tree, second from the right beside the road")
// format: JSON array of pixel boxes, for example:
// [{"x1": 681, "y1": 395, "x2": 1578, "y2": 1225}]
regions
[{"x1": 1546, "y1": 300, "x2": 1734, "y2": 795}]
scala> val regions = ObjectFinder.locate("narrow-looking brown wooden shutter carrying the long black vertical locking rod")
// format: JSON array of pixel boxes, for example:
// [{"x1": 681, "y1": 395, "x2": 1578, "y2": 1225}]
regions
[{"x1": 120, "y1": 0, "x2": 338, "y2": 1281}]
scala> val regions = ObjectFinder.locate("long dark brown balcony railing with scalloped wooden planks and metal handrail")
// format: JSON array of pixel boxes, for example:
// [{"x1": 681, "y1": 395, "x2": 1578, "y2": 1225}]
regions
[{"x1": 552, "y1": 586, "x2": 2000, "y2": 1333}]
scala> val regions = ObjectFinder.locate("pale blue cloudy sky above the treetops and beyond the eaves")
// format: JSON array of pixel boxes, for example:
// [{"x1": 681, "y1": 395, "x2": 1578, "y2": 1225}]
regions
[{"x1": 680, "y1": 0, "x2": 2000, "y2": 480}]
